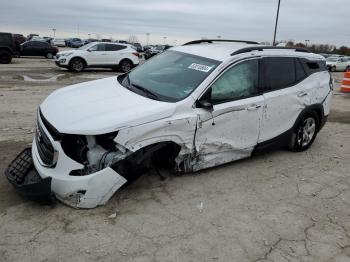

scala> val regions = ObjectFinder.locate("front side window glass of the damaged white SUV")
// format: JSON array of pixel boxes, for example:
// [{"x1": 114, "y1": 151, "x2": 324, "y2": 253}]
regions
[{"x1": 211, "y1": 59, "x2": 259, "y2": 104}]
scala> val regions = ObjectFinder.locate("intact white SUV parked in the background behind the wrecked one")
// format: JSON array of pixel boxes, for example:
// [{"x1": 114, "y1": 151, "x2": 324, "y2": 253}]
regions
[{"x1": 55, "y1": 42, "x2": 139, "y2": 73}]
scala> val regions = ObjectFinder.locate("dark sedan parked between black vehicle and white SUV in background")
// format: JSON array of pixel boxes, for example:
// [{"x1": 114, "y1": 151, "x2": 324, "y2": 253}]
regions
[{"x1": 21, "y1": 40, "x2": 58, "y2": 59}]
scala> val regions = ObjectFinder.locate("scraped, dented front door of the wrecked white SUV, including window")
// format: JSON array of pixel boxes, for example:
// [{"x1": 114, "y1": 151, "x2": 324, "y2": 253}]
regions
[{"x1": 193, "y1": 59, "x2": 264, "y2": 171}]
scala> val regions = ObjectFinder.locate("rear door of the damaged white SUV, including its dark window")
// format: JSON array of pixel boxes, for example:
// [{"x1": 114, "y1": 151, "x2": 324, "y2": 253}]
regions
[{"x1": 259, "y1": 57, "x2": 312, "y2": 143}]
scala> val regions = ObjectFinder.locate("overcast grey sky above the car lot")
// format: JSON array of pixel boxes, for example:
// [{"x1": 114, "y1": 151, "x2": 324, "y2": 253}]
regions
[{"x1": 0, "y1": 0, "x2": 350, "y2": 46}]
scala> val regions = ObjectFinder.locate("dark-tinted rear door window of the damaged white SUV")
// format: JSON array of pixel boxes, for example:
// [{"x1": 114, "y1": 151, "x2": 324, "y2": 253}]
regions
[{"x1": 262, "y1": 57, "x2": 296, "y2": 90}]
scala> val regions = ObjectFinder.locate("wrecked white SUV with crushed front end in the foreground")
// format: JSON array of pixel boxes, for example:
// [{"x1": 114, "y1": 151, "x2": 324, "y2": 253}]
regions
[{"x1": 6, "y1": 40, "x2": 333, "y2": 208}]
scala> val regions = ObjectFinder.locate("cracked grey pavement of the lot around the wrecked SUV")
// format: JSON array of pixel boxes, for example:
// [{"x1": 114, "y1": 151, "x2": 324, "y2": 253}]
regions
[{"x1": 0, "y1": 59, "x2": 350, "y2": 262}]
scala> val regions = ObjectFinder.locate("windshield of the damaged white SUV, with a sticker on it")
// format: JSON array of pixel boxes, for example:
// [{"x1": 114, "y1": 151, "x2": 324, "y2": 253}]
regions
[{"x1": 122, "y1": 51, "x2": 220, "y2": 102}]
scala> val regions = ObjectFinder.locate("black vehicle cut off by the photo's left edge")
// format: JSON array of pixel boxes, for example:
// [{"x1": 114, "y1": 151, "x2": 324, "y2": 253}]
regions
[{"x1": 0, "y1": 32, "x2": 19, "y2": 64}]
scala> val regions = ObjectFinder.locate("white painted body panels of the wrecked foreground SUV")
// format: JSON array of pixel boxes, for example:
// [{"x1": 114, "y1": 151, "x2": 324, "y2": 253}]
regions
[{"x1": 33, "y1": 44, "x2": 331, "y2": 208}]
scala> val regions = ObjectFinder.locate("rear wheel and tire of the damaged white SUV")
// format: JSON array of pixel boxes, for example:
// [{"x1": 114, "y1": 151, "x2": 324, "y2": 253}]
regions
[{"x1": 289, "y1": 111, "x2": 320, "y2": 152}]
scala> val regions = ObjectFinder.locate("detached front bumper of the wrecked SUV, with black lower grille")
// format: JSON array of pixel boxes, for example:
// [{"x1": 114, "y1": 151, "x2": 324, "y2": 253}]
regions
[{"x1": 5, "y1": 112, "x2": 127, "y2": 208}]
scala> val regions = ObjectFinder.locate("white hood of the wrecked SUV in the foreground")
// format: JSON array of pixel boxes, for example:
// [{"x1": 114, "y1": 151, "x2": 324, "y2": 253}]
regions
[{"x1": 40, "y1": 76, "x2": 176, "y2": 135}]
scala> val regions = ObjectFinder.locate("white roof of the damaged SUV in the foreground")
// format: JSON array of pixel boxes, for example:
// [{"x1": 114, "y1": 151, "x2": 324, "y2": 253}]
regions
[{"x1": 171, "y1": 42, "x2": 324, "y2": 61}]
